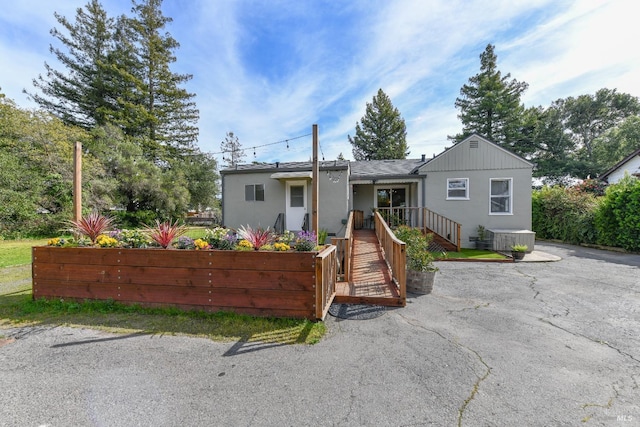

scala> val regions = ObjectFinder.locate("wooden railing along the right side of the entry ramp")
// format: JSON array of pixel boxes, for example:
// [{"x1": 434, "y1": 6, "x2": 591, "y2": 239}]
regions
[{"x1": 374, "y1": 212, "x2": 407, "y2": 303}]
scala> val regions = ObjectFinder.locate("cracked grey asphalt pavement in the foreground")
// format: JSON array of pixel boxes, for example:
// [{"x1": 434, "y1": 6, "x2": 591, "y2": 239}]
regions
[{"x1": 0, "y1": 242, "x2": 640, "y2": 426}]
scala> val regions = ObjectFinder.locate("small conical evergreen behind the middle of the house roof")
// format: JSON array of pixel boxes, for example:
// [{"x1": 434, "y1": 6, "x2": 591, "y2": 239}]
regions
[{"x1": 348, "y1": 89, "x2": 409, "y2": 160}]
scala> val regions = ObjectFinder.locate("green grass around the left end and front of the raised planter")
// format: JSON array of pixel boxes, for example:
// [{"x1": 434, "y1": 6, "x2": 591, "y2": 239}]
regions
[{"x1": 0, "y1": 236, "x2": 326, "y2": 344}]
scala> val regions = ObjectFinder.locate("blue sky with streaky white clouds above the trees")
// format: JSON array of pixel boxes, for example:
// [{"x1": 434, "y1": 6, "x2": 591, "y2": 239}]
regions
[{"x1": 0, "y1": 0, "x2": 640, "y2": 166}]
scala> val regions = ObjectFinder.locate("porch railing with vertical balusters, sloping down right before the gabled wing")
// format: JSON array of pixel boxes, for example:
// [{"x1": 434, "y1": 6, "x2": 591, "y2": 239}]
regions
[{"x1": 378, "y1": 207, "x2": 461, "y2": 252}]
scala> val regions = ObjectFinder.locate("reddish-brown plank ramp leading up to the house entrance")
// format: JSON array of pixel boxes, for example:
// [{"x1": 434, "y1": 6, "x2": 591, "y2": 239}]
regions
[{"x1": 334, "y1": 229, "x2": 402, "y2": 306}]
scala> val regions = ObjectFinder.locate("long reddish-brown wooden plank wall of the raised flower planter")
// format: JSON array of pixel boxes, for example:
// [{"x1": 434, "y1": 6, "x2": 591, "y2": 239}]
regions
[{"x1": 32, "y1": 246, "x2": 336, "y2": 320}]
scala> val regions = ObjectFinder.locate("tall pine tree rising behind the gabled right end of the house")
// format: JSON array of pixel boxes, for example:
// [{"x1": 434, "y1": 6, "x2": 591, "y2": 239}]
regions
[{"x1": 450, "y1": 44, "x2": 528, "y2": 152}]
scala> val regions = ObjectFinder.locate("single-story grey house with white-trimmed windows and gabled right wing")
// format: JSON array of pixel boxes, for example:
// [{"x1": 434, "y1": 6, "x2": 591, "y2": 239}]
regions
[{"x1": 220, "y1": 135, "x2": 534, "y2": 250}]
